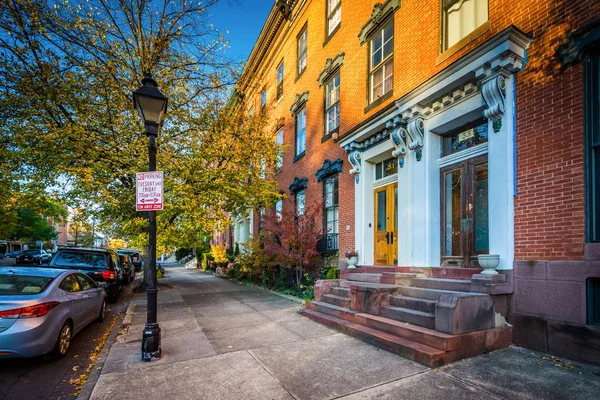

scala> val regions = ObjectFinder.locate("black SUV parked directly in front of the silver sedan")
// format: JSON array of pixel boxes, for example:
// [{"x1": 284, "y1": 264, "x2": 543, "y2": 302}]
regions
[{"x1": 50, "y1": 247, "x2": 125, "y2": 303}]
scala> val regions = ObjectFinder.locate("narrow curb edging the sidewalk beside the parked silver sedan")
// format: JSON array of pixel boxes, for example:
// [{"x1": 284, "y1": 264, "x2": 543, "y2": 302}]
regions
[{"x1": 77, "y1": 274, "x2": 142, "y2": 400}]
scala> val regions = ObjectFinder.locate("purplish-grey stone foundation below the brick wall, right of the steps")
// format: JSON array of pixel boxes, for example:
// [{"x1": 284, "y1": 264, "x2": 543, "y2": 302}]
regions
[{"x1": 508, "y1": 260, "x2": 600, "y2": 364}]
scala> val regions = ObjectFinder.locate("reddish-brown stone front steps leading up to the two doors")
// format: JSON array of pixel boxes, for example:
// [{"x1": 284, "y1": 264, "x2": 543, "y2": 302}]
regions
[{"x1": 300, "y1": 267, "x2": 512, "y2": 367}]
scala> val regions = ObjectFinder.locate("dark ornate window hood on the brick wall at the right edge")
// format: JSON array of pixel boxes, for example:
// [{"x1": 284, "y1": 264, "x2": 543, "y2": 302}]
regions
[{"x1": 555, "y1": 18, "x2": 600, "y2": 69}]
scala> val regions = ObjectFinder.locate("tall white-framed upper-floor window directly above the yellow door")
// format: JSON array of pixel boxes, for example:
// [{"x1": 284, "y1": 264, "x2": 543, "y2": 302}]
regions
[{"x1": 369, "y1": 19, "x2": 394, "y2": 102}]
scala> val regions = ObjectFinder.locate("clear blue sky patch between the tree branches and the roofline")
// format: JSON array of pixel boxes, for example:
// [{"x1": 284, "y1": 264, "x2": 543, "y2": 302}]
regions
[{"x1": 210, "y1": 0, "x2": 275, "y2": 60}]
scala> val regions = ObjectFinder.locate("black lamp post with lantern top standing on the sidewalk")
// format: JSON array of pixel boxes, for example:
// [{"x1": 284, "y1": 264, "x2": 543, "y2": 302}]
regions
[{"x1": 133, "y1": 74, "x2": 168, "y2": 361}]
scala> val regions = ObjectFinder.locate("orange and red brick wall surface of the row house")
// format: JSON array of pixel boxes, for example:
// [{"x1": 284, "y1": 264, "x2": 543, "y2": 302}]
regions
[{"x1": 244, "y1": 0, "x2": 600, "y2": 260}]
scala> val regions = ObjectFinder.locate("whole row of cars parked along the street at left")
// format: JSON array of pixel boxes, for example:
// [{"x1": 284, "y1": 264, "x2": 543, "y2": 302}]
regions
[{"x1": 0, "y1": 248, "x2": 141, "y2": 358}]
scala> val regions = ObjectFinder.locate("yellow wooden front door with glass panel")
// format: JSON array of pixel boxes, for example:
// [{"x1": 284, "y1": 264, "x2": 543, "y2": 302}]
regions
[{"x1": 375, "y1": 183, "x2": 398, "y2": 265}]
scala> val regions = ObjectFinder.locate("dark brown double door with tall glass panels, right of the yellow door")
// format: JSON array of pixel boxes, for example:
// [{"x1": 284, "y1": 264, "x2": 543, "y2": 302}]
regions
[{"x1": 440, "y1": 156, "x2": 489, "y2": 267}]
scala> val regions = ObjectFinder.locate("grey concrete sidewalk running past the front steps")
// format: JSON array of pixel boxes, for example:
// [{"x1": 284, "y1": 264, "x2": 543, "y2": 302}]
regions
[{"x1": 92, "y1": 268, "x2": 600, "y2": 400}]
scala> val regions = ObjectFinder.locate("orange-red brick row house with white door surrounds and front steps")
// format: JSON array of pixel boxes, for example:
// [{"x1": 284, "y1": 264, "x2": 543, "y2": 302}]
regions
[{"x1": 236, "y1": 0, "x2": 600, "y2": 365}]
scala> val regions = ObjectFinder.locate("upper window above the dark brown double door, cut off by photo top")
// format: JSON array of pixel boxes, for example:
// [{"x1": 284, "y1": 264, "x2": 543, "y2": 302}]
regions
[{"x1": 442, "y1": 0, "x2": 489, "y2": 50}]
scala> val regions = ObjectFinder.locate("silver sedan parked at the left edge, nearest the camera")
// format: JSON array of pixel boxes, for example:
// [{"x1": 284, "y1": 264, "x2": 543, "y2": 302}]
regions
[{"x1": 0, "y1": 267, "x2": 106, "y2": 358}]
